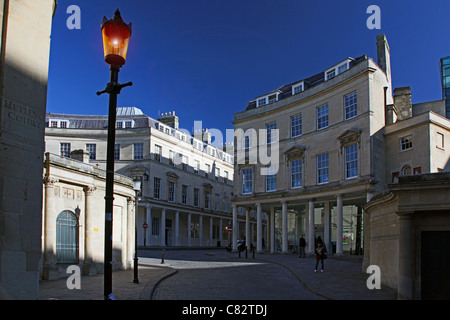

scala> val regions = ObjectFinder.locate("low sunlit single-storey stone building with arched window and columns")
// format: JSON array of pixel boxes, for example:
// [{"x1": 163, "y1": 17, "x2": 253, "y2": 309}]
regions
[{"x1": 41, "y1": 150, "x2": 136, "y2": 280}]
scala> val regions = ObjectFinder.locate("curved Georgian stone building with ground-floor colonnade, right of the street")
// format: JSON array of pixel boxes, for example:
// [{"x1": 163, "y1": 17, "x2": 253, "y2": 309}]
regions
[{"x1": 233, "y1": 35, "x2": 450, "y2": 268}]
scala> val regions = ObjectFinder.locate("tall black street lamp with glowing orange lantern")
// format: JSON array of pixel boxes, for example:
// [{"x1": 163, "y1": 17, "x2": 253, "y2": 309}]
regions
[{"x1": 97, "y1": 9, "x2": 132, "y2": 300}]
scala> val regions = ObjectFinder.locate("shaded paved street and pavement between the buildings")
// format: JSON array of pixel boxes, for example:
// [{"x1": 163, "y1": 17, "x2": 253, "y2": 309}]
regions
[{"x1": 39, "y1": 249, "x2": 396, "y2": 300}]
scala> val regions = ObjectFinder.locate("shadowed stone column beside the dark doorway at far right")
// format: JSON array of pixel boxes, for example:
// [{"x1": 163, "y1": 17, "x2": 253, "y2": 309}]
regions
[{"x1": 397, "y1": 214, "x2": 412, "y2": 300}]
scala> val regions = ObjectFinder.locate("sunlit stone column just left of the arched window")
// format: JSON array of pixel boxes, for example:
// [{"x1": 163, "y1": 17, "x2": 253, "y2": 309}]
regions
[{"x1": 43, "y1": 176, "x2": 60, "y2": 280}]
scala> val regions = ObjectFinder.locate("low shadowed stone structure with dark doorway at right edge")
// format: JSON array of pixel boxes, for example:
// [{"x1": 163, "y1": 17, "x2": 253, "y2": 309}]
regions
[{"x1": 364, "y1": 172, "x2": 450, "y2": 299}]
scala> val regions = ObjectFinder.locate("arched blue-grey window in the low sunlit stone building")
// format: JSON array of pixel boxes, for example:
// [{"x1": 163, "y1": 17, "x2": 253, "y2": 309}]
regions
[{"x1": 56, "y1": 210, "x2": 78, "y2": 263}]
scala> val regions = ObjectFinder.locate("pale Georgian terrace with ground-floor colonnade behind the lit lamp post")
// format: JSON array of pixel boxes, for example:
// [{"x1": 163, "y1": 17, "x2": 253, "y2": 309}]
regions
[{"x1": 45, "y1": 107, "x2": 243, "y2": 247}]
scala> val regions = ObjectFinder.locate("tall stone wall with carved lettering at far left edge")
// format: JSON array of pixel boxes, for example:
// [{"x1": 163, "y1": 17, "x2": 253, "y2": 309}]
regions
[{"x1": 0, "y1": 0, "x2": 56, "y2": 299}]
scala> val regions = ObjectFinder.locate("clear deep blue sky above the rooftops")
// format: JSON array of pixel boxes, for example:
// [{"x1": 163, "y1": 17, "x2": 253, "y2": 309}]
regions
[{"x1": 47, "y1": 0, "x2": 450, "y2": 144}]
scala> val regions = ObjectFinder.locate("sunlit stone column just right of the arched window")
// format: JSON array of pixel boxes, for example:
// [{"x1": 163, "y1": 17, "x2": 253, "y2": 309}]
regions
[{"x1": 83, "y1": 186, "x2": 97, "y2": 276}]
